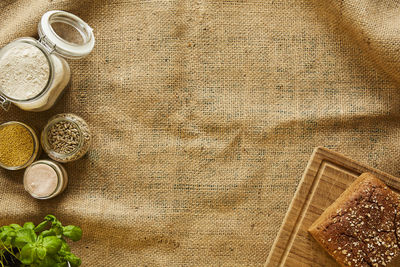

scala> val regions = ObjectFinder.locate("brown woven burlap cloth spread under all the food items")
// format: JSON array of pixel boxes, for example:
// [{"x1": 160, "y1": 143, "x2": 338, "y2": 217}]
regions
[{"x1": 0, "y1": 0, "x2": 400, "y2": 266}]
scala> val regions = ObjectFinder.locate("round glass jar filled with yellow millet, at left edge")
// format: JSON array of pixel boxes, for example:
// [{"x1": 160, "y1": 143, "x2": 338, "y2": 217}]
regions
[{"x1": 0, "y1": 121, "x2": 40, "y2": 170}]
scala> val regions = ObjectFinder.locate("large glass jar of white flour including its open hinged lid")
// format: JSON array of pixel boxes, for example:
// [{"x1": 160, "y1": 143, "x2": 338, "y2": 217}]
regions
[{"x1": 0, "y1": 10, "x2": 95, "y2": 111}]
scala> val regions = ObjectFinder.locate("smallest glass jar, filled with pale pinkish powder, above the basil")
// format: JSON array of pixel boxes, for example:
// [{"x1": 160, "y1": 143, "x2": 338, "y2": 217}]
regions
[{"x1": 24, "y1": 160, "x2": 68, "y2": 199}]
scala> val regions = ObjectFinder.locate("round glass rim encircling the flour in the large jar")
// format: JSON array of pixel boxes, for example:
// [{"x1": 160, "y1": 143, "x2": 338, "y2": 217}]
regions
[{"x1": 0, "y1": 37, "x2": 54, "y2": 103}]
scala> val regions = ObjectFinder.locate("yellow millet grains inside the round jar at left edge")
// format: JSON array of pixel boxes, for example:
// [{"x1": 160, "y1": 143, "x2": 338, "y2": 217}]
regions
[{"x1": 0, "y1": 124, "x2": 34, "y2": 167}]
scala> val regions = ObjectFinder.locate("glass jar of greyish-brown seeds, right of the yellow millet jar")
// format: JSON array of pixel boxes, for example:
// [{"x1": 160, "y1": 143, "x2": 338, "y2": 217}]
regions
[{"x1": 41, "y1": 113, "x2": 92, "y2": 162}]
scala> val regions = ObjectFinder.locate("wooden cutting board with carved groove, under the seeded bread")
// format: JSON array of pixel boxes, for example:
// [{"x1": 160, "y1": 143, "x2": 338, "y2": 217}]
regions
[{"x1": 265, "y1": 147, "x2": 400, "y2": 267}]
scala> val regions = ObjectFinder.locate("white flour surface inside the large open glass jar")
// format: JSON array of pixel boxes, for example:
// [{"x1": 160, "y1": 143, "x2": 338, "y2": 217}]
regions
[{"x1": 0, "y1": 43, "x2": 50, "y2": 100}]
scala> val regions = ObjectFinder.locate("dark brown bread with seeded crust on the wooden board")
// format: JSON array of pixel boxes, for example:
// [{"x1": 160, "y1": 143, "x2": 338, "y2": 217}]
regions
[{"x1": 308, "y1": 173, "x2": 400, "y2": 267}]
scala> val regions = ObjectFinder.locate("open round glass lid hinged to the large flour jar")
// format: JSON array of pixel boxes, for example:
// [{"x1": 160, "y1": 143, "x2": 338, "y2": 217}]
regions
[{"x1": 38, "y1": 10, "x2": 95, "y2": 58}]
